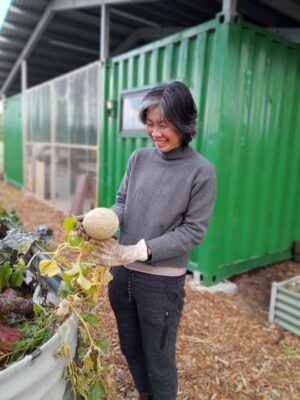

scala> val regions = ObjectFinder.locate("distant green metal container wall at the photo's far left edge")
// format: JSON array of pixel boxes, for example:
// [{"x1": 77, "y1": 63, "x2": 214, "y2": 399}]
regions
[{"x1": 3, "y1": 95, "x2": 23, "y2": 187}]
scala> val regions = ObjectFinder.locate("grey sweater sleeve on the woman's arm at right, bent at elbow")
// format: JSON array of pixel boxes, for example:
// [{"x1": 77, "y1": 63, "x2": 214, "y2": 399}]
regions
[{"x1": 147, "y1": 175, "x2": 216, "y2": 263}]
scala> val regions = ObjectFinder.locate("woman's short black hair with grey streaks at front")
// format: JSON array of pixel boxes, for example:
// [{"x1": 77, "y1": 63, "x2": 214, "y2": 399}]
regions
[{"x1": 139, "y1": 81, "x2": 197, "y2": 148}]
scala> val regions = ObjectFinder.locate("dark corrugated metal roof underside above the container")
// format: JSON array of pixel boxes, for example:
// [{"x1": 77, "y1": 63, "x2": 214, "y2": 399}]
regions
[{"x1": 0, "y1": 0, "x2": 300, "y2": 96}]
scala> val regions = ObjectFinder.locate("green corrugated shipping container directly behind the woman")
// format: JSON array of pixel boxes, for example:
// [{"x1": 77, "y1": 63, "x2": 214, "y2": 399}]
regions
[{"x1": 99, "y1": 18, "x2": 300, "y2": 285}]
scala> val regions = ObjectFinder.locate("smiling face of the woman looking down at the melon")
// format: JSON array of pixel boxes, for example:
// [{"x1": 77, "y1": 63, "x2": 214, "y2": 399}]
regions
[{"x1": 145, "y1": 107, "x2": 181, "y2": 153}]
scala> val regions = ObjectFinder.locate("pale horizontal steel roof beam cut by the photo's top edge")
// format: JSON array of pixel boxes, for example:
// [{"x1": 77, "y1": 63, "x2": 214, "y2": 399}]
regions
[{"x1": 53, "y1": 0, "x2": 158, "y2": 11}]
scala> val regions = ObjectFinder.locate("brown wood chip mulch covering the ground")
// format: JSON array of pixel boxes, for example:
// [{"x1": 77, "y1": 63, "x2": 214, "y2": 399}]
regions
[{"x1": 0, "y1": 182, "x2": 300, "y2": 400}]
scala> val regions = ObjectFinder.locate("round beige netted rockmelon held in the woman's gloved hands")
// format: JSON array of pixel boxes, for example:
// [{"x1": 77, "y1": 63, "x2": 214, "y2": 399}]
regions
[{"x1": 82, "y1": 207, "x2": 119, "y2": 240}]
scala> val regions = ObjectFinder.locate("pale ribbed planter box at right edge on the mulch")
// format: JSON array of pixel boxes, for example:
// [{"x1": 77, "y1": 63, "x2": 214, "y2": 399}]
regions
[{"x1": 269, "y1": 276, "x2": 300, "y2": 336}]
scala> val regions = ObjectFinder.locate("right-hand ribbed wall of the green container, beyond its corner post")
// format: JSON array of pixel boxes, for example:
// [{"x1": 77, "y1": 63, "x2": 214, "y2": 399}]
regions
[{"x1": 198, "y1": 18, "x2": 300, "y2": 281}]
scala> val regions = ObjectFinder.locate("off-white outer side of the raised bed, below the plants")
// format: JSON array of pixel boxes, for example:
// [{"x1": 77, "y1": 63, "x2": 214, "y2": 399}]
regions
[{"x1": 0, "y1": 316, "x2": 77, "y2": 400}]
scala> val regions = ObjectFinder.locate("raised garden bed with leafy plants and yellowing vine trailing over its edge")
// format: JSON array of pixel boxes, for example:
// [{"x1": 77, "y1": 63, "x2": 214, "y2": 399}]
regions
[{"x1": 0, "y1": 206, "x2": 113, "y2": 400}]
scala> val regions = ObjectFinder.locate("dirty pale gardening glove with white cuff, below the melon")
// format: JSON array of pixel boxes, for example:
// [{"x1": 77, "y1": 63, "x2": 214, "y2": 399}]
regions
[{"x1": 90, "y1": 238, "x2": 148, "y2": 267}]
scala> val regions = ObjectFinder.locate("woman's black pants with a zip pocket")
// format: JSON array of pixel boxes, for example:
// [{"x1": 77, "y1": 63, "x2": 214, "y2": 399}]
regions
[{"x1": 109, "y1": 266, "x2": 185, "y2": 400}]
